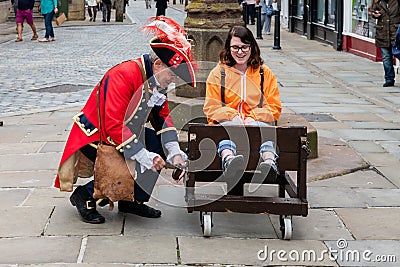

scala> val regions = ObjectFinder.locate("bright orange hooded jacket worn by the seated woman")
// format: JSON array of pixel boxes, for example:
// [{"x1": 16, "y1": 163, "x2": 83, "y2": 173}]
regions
[{"x1": 203, "y1": 63, "x2": 282, "y2": 124}]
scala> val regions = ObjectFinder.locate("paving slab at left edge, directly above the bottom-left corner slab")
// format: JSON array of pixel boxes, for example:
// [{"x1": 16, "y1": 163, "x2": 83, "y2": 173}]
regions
[{"x1": 0, "y1": 207, "x2": 53, "y2": 240}]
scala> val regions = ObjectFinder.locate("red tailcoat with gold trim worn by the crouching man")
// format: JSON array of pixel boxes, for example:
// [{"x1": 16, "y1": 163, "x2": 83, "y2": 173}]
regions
[{"x1": 55, "y1": 56, "x2": 178, "y2": 191}]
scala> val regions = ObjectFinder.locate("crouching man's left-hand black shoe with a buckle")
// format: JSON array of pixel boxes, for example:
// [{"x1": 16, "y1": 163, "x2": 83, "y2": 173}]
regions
[{"x1": 69, "y1": 186, "x2": 106, "y2": 224}]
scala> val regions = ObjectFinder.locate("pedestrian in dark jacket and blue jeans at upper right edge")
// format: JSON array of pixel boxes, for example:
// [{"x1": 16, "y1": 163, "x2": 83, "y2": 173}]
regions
[{"x1": 371, "y1": 0, "x2": 400, "y2": 87}]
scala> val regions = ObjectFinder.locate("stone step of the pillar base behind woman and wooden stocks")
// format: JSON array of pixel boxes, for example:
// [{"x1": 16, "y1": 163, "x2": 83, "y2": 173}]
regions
[{"x1": 168, "y1": 93, "x2": 318, "y2": 159}]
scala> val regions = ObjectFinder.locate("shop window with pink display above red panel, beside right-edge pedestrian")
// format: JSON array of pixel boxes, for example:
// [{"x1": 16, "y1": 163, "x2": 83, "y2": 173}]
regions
[{"x1": 352, "y1": 0, "x2": 375, "y2": 38}]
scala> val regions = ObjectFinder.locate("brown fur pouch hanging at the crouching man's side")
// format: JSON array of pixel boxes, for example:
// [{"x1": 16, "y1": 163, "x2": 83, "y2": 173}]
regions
[{"x1": 93, "y1": 143, "x2": 136, "y2": 202}]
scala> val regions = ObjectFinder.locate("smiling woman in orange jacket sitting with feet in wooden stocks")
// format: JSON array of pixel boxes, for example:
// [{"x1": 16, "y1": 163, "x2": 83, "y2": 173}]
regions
[{"x1": 203, "y1": 26, "x2": 282, "y2": 184}]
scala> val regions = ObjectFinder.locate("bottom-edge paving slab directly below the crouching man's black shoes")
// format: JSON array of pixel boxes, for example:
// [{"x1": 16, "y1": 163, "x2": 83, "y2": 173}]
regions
[{"x1": 83, "y1": 235, "x2": 178, "y2": 264}]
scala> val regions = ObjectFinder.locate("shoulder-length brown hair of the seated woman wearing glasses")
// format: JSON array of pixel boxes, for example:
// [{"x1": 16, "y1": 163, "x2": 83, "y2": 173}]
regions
[{"x1": 219, "y1": 26, "x2": 264, "y2": 68}]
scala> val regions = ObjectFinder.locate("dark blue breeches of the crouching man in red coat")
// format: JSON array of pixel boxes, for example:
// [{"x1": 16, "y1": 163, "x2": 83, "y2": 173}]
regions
[{"x1": 80, "y1": 128, "x2": 166, "y2": 202}]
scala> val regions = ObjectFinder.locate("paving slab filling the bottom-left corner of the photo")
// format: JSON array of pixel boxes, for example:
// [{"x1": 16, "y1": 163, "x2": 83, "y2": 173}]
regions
[{"x1": 0, "y1": 236, "x2": 81, "y2": 266}]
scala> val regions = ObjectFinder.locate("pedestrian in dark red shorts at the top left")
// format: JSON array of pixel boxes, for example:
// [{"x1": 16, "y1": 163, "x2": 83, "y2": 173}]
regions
[{"x1": 15, "y1": 0, "x2": 38, "y2": 42}]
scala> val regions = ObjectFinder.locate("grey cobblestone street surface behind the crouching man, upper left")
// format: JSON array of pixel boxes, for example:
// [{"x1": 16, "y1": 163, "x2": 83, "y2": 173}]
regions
[{"x1": 0, "y1": 1, "x2": 185, "y2": 117}]
